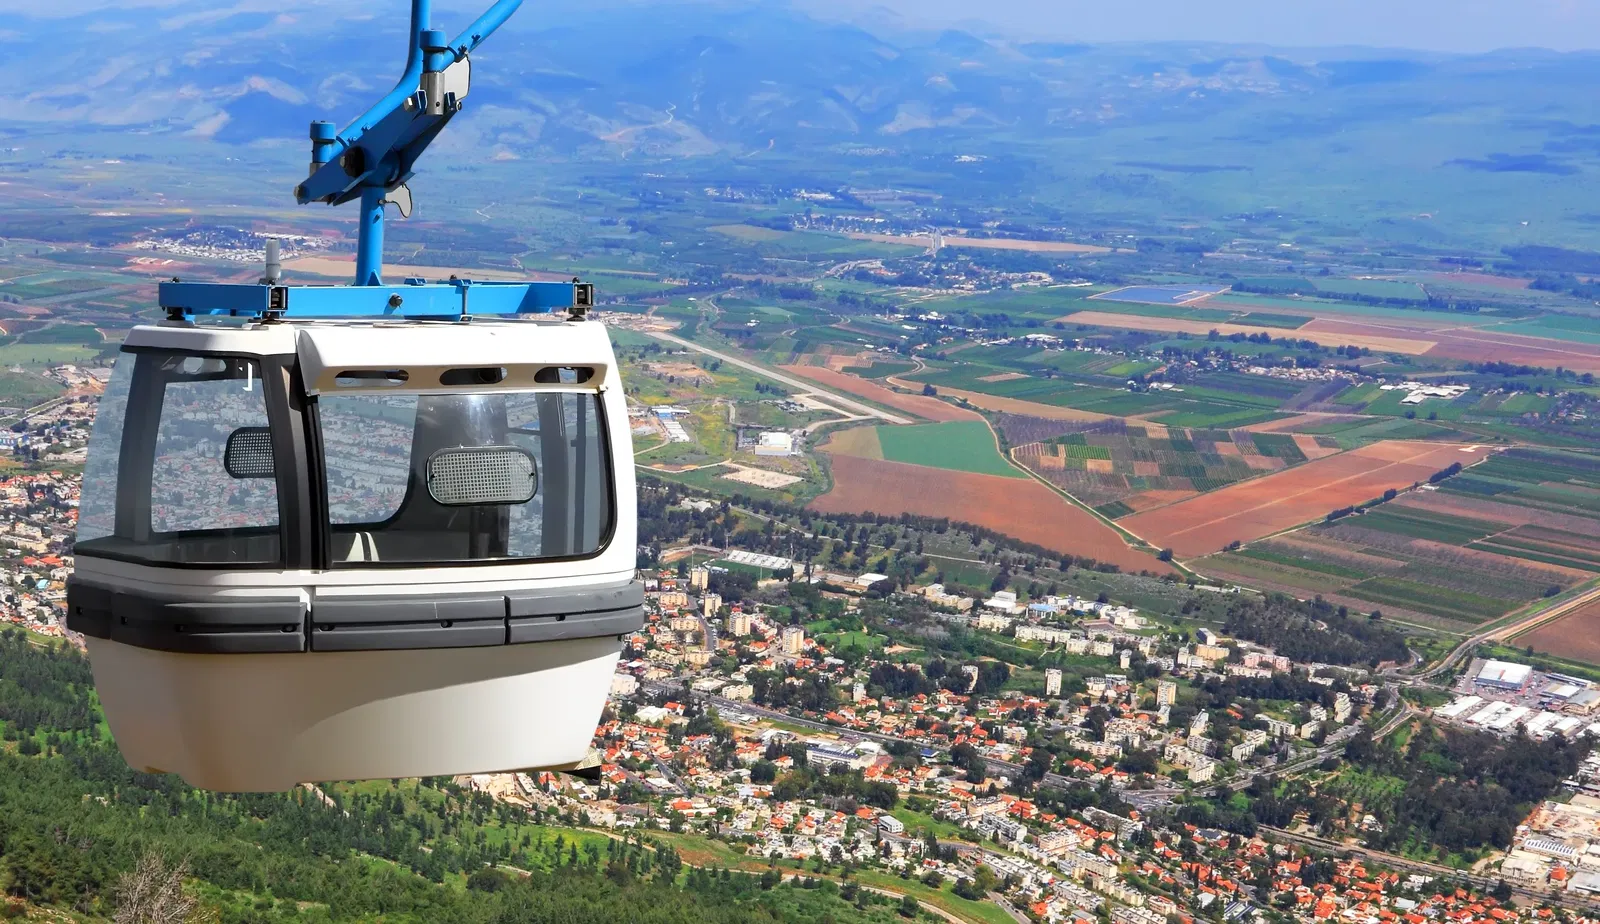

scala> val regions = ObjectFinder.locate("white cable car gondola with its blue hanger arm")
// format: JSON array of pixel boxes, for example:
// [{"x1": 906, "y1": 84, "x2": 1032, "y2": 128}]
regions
[{"x1": 67, "y1": 0, "x2": 643, "y2": 791}]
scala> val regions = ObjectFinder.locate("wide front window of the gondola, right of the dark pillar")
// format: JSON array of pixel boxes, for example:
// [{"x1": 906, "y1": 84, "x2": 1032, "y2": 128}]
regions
[{"x1": 317, "y1": 392, "x2": 613, "y2": 568}]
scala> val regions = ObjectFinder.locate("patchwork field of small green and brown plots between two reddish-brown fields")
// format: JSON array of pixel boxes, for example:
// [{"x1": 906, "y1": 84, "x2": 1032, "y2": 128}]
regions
[{"x1": 1013, "y1": 420, "x2": 1338, "y2": 520}]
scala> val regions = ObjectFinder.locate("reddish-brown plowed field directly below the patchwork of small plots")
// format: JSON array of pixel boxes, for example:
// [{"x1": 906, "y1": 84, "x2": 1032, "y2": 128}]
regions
[{"x1": 1117, "y1": 440, "x2": 1488, "y2": 558}]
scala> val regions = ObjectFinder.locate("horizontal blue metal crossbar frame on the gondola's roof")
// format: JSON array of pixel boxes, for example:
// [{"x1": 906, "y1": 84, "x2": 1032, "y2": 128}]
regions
[{"x1": 158, "y1": 280, "x2": 592, "y2": 318}]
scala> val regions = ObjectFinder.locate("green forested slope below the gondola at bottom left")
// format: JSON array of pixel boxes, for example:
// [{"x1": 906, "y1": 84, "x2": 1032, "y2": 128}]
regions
[{"x1": 0, "y1": 630, "x2": 898, "y2": 924}]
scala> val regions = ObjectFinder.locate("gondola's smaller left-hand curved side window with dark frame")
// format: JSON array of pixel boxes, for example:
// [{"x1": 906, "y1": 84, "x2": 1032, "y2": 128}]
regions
[{"x1": 77, "y1": 352, "x2": 282, "y2": 564}]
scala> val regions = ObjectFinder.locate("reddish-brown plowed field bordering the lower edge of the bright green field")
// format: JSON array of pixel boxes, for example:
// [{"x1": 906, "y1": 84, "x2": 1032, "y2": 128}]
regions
[{"x1": 811, "y1": 454, "x2": 1168, "y2": 572}]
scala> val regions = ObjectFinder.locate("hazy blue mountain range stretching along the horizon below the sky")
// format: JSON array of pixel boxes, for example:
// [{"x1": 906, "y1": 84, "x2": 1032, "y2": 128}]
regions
[{"x1": 9, "y1": 0, "x2": 1600, "y2": 251}]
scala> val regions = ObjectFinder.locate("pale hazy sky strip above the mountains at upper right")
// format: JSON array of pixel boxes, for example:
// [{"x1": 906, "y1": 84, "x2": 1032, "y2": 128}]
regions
[{"x1": 797, "y1": 0, "x2": 1600, "y2": 51}]
